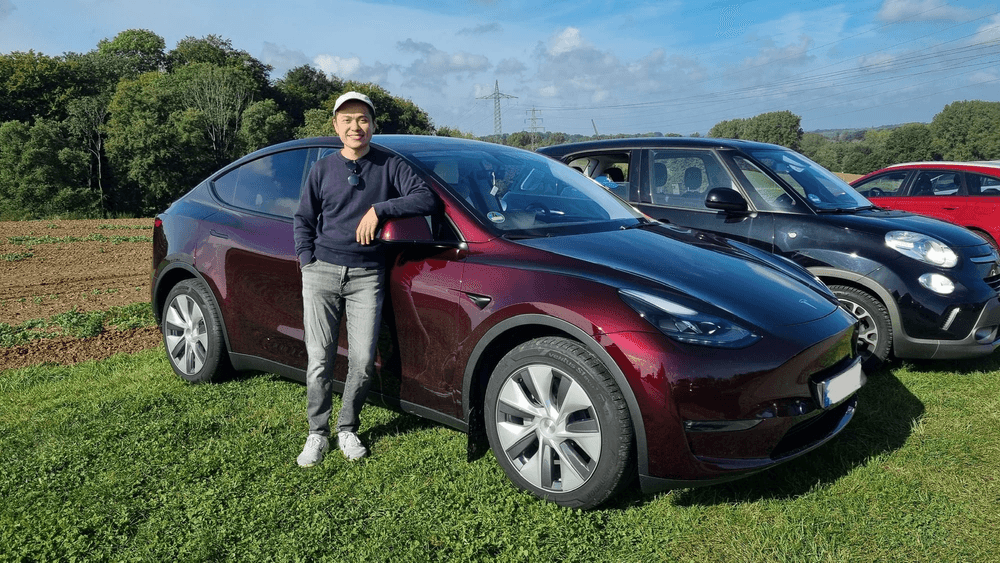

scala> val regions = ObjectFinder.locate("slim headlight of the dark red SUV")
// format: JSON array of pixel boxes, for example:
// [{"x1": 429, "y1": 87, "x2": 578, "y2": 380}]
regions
[{"x1": 619, "y1": 289, "x2": 760, "y2": 348}]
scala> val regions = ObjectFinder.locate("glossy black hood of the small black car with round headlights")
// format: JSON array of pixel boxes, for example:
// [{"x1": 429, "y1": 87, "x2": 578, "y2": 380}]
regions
[{"x1": 824, "y1": 210, "x2": 984, "y2": 248}]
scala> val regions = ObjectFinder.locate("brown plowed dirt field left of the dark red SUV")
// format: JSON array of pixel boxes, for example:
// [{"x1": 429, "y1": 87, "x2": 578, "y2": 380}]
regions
[{"x1": 0, "y1": 219, "x2": 160, "y2": 371}]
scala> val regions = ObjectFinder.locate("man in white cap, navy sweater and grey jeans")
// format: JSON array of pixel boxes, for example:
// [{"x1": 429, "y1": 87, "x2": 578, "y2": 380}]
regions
[{"x1": 295, "y1": 92, "x2": 436, "y2": 467}]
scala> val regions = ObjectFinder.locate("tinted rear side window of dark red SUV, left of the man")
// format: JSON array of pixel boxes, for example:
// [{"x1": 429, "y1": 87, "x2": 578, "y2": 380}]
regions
[{"x1": 213, "y1": 149, "x2": 316, "y2": 217}]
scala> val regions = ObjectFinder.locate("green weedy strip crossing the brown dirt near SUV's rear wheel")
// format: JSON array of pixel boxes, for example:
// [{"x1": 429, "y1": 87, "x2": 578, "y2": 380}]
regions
[{"x1": 0, "y1": 304, "x2": 156, "y2": 348}]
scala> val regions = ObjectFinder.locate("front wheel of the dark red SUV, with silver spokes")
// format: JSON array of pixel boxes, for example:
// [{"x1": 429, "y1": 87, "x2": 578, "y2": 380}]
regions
[{"x1": 484, "y1": 337, "x2": 635, "y2": 509}]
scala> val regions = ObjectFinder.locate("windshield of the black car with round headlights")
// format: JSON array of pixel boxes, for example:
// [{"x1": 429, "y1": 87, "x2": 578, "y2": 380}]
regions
[{"x1": 748, "y1": 149, "x2": 872, "y2": 211}]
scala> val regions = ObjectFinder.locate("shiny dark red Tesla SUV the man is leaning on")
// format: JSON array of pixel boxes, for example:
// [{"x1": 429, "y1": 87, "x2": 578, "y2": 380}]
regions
[{"x1": 152, "y1": 136, "x2": 865, "y2": 507}]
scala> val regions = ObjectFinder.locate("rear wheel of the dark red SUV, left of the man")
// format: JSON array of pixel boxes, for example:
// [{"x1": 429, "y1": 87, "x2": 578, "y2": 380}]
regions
[{"x1": 160, "y1": 279, "x2": 230, "y2": 383}]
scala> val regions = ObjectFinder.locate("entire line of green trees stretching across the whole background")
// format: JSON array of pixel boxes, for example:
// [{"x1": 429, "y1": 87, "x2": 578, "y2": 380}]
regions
[{"x1": 0, "y1": 29, "x2": 1000, "y2": 220}]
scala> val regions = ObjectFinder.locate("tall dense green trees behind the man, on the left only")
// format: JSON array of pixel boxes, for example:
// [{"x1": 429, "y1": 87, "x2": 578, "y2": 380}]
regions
[{"x1": 0, "y1": 30, "x2": 434, "y2": 220}]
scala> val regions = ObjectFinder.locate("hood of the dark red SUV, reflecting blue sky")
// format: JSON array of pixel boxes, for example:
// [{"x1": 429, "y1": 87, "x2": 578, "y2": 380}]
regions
[{"x1": 517, "y1": 226, "x2": 838, "y2": 327}]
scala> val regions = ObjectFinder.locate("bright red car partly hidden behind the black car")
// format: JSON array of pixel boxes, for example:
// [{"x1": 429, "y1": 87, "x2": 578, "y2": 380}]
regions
[{"x1": 851, "y1": 161, "x2": 1000, "y2": 248}]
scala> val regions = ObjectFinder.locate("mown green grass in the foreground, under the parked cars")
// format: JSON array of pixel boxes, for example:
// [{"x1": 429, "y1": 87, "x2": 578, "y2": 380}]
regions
[{"x1": 0, "y1": 350, "x2": 1000, "y2": 562}]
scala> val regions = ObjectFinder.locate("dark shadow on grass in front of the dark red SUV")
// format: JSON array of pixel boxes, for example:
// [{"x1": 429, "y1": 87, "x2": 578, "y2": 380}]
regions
[{"x1": 607, "y1": 368, "x2": 924, "y2": 508}]
